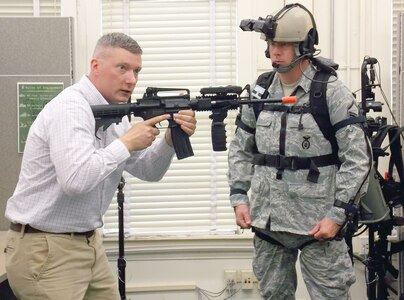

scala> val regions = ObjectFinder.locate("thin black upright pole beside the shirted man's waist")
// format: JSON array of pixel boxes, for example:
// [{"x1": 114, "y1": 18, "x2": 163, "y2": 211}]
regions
[{"x1": 117, "y1": 176, "x2": 126, "y2": 300}]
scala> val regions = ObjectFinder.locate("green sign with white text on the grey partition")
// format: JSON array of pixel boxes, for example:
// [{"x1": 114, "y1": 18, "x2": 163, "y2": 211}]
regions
[{"x1": 17, "y1": 82, "x2": 63, "y2": 153}]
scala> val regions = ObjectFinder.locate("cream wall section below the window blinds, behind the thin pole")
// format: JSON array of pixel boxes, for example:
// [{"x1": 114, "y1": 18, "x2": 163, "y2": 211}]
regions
[{"x1": 105, "y1": 236, "x2": 312, "y2": 300}]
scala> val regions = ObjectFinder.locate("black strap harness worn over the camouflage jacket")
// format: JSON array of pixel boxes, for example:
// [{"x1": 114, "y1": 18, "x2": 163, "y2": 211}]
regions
[{"x1": 236, "y1": 70, "x2": 366, "y2": 183}]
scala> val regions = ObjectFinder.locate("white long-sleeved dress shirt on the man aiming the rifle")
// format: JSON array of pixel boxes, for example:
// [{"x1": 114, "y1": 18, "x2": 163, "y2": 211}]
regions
[{"x1": 5, "y1": 76, "x2": 174, "y2": 232}]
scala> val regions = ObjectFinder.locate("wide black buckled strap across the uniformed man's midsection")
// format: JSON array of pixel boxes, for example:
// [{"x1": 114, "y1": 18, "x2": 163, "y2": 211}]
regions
[{"x1": 252, "y1": 153, "x2": 340, "y2": 183}]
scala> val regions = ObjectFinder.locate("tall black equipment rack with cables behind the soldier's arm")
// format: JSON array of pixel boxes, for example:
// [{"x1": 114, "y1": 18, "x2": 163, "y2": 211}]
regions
[{"x1": 359, "y1": 57, "x2": 404, "y2": 300}]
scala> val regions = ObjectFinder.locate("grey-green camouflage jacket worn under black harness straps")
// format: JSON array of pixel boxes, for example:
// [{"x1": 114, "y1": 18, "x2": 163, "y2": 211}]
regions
[{"x1": 228, "y1": 66, "x2": 370, "y2": 235}]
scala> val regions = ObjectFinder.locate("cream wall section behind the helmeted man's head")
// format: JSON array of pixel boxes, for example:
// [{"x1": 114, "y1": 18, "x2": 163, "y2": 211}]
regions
[{"x1": 238, "y1": 0, "x2": 392, "y2": 103}]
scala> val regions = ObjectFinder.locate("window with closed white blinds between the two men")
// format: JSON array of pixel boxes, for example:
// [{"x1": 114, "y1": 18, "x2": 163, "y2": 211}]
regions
[{"x1": 102, "y1": 0, "x2": 237, "y2": 236}]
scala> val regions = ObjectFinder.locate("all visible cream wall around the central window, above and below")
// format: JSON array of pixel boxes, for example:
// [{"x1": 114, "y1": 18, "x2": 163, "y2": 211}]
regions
[{"x1": 62, "y1": 0, "x2": 392, "y2": 300}]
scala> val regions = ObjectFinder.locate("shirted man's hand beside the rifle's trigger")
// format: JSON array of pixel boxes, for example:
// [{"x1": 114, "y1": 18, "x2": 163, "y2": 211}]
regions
[{"x1": 119, "y1": 114, "x2": 170, "y2": 152}]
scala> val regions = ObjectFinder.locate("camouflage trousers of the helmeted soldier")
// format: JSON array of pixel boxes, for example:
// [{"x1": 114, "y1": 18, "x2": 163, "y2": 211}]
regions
[{"x1": 253, "y1": 232, "x2": 355, "y2": 300}]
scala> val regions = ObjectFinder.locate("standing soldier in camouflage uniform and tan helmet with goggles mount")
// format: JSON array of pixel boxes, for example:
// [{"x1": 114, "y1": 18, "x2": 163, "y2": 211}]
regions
[{"x1": 228, "y1": 4, "x2": 372, "y2": 300}]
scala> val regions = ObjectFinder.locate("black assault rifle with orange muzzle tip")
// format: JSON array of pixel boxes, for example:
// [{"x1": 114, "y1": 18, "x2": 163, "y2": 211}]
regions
[{"x1": 91, "y1": 85, "x2": 296, "y2": 159}]
